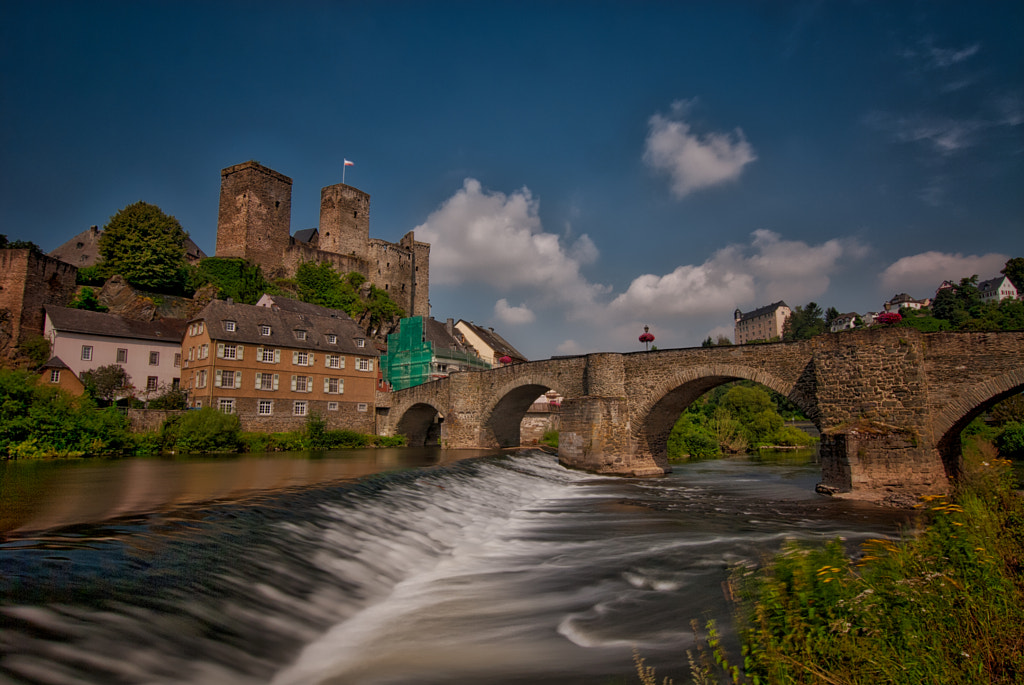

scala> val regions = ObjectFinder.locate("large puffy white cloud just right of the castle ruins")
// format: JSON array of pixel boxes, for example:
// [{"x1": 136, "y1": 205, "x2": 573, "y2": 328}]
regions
[{"x1": 415, "y1": 178, "x2": 606, "y2": 309}]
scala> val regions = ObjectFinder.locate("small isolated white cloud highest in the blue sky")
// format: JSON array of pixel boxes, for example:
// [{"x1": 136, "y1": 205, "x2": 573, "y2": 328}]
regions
[{"x1": 643, "y1": 100, "x2": 757, "y2": 198}]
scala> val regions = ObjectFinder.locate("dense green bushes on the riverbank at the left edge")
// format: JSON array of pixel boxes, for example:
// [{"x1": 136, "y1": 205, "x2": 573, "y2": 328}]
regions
[{"x1": 0, "y1": 371, "x2": 129, "y2": 459}]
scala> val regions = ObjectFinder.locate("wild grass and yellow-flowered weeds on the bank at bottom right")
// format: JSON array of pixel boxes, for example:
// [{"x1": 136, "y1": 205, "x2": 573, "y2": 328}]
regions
[{"x1": 637, "y1": 440, "x2": 1024, "y2": 685}]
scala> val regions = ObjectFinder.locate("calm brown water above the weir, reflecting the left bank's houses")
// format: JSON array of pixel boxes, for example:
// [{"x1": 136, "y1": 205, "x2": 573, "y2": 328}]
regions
[{"x1": 0, "y1": 447, "x2": 494, "y2": 538}]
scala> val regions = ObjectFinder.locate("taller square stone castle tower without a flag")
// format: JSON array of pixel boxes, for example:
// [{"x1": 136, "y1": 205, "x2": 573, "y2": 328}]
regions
[{"x1": 216, "y1": 162, "x2": 292, "y2": 276}]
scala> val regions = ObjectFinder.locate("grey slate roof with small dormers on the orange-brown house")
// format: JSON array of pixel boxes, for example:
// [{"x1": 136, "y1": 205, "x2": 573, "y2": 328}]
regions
[{"x1": 189, "y1": 297, "x2": 378, "y2": 356}]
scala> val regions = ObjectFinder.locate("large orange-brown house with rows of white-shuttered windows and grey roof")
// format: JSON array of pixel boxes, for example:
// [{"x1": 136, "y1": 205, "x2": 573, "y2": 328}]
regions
[{"x1": 181, "y1": 296, "x2": 378, "y2": 433}]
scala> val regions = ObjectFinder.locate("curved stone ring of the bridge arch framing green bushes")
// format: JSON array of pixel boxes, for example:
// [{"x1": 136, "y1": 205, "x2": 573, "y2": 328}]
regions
[{"x1": 633, "y1": 365, "x2": 820, "y2": 466}]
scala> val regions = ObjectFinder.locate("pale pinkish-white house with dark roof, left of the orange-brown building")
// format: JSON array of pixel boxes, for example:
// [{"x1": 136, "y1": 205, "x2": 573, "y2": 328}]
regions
[{"x1": 43, "y1": 306, "x2": 185, "y2": 399}]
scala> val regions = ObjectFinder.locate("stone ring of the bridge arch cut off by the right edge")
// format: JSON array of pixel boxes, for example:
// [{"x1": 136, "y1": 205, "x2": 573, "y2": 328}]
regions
[{"x1": 933, "y1": 369, "x2": 1024, "y2": 476}]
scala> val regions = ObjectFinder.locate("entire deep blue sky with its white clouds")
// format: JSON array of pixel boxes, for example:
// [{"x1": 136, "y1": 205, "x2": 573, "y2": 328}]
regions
[{"x1": 0, "y1": 0, "x2": 1024, "y2": 358}]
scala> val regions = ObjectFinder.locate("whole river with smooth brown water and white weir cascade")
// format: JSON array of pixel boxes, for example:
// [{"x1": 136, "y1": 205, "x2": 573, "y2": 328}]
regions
[{"x1": 0, "y1": 449, "x2": 907, "y2": 685}]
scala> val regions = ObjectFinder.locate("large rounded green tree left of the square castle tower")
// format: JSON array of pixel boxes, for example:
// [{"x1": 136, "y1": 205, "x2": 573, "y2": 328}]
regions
[{"x1": 99, "y1": 202, "x2": 186, "y2": 292}]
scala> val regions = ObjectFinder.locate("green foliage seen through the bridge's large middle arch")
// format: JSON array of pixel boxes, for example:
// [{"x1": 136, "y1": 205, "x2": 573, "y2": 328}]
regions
[{"x1": 667, "y1": 381, "x2": 814, "y2": 461}]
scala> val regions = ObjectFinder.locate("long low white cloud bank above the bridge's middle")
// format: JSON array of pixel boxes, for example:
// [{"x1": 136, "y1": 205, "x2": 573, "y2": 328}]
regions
[{"x1": 610, "y1": 229, "x2": 867, "y2": 316}]
